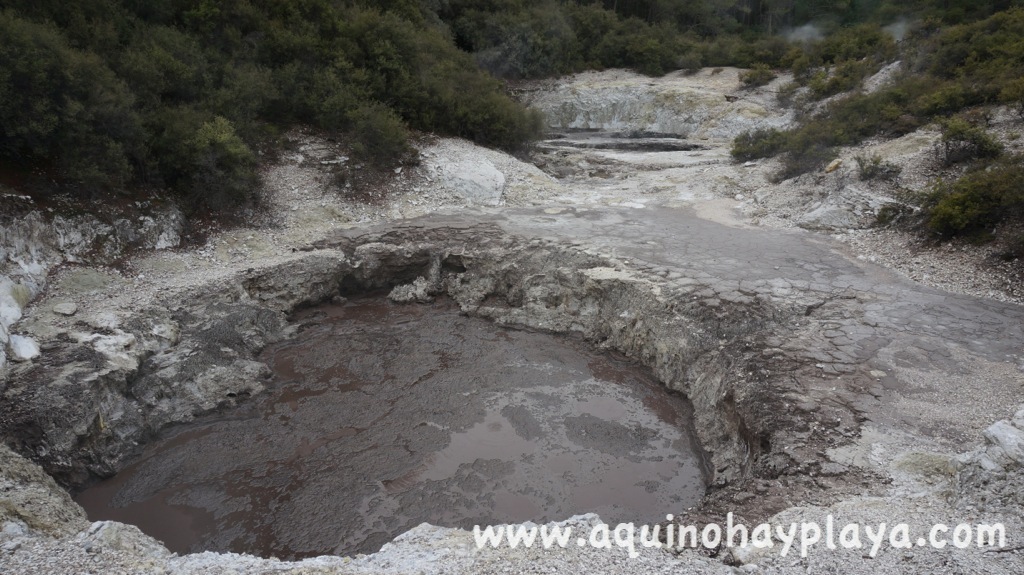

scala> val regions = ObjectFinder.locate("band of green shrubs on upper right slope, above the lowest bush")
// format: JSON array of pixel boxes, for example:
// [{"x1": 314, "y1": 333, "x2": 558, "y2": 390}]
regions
[{"x1": 733, "y1": 9, "x2": 1024, "y2": 178}]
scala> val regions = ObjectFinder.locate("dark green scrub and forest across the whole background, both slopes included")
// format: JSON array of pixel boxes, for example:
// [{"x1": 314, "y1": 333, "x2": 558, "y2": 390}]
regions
[{"x1": 0, "y1": 0, "x2": 1024, "y2": 216}]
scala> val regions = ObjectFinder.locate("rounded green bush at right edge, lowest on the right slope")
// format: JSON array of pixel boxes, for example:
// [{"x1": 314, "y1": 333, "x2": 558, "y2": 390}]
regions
[{"x1": 926, "y1": 157, "x2": 1024, "y2": 237}]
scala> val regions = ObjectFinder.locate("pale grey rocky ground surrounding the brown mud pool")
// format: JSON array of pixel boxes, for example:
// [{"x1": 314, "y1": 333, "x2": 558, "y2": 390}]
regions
[{"x1": 0, "y1": 64, "x2": 1024, "y2": 574}]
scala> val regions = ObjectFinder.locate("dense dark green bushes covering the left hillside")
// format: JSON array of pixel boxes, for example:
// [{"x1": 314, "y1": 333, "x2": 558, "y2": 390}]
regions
[{"x1": 0, "y1": 0, "x2": 540, "y2": 210}]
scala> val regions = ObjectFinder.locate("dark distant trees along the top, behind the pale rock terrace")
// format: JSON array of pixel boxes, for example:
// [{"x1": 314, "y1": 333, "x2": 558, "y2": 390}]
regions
[{"x1": 437, "y1": 0, "x2": 1013, "y2": 78}]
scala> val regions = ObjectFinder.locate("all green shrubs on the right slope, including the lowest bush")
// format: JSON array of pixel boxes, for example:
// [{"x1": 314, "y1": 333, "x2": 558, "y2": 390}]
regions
[{"x1": 732, "y1": 2, "x2": 1024, "y2": 247}]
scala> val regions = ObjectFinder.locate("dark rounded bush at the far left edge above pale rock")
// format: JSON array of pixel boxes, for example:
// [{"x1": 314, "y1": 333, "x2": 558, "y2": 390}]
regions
[{"x1": 0, "y1": 11, "x2": 143, "y2": 193}]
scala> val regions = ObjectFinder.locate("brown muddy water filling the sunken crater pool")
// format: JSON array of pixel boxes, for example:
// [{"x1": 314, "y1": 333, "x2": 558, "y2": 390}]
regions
[{"x1": 78, "y1": 299, "x2": 705, "y2": 558}]
